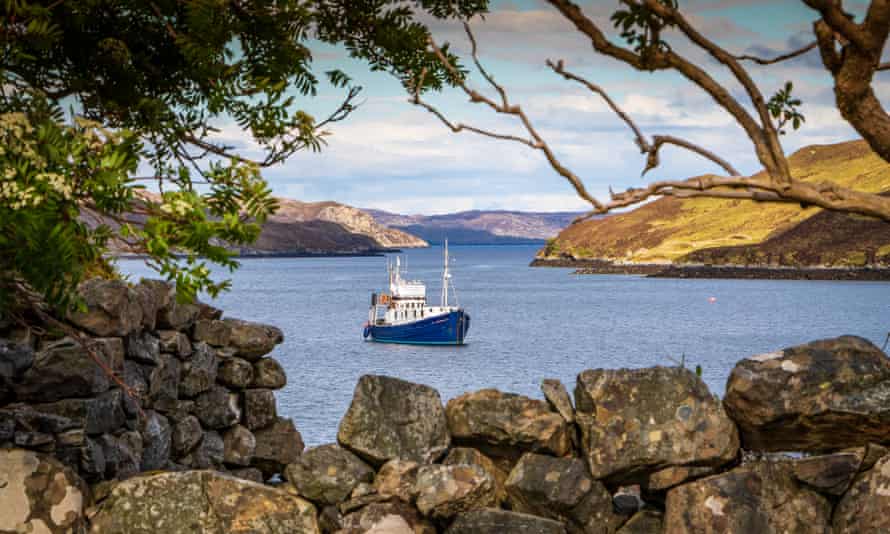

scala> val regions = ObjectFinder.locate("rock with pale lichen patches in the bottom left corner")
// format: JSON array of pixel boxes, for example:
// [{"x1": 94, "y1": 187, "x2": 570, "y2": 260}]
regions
[{"x1": 0, "y1": 449, "x2": 87, "y2": 534}]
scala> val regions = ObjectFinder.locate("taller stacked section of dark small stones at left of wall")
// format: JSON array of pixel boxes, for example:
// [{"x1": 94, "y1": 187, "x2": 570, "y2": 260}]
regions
[{"x1": 0, "y1": 279, "x2": 303, "y2": 488}]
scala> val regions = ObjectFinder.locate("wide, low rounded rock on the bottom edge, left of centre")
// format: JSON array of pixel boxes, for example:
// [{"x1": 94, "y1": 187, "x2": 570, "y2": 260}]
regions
[{"x1": 92, "y1": 471, "x2": 319, "y2": 534}]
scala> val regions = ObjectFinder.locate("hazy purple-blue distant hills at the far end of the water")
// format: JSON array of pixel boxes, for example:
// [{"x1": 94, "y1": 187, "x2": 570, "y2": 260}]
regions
[{"x1": 365, "y1": 209, "x2": 579, "y2": 245}]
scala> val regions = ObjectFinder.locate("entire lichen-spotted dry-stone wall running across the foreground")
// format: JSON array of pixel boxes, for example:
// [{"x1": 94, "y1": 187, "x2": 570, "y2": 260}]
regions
[{"x1": 0, "y1": 280, "x2": 890, "y2": 534}]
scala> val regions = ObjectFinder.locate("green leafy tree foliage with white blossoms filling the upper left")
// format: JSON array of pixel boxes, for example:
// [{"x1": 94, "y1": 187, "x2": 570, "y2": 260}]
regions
[{"x1": 0, "y1": 0, "x2": 487, "y2": 308}]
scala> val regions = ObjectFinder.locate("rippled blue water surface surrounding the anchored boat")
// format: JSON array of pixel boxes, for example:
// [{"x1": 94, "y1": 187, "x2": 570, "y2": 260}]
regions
[{"x1": 119, "y1": 246, "x2": 890, "y2": 445}]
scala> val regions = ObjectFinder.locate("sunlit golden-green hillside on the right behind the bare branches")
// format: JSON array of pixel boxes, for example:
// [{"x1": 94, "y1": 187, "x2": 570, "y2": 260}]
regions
[{"x1": 538, "y1": 141, "x2": 890, "y2": 266}]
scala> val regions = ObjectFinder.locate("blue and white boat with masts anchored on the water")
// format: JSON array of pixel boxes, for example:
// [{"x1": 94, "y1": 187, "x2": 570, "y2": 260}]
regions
[{"x1": 363, "y1": 240, "x2": 470, "y2": 345}]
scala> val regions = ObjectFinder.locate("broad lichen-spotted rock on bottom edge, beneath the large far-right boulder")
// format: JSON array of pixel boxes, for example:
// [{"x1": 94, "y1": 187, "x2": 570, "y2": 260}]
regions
[{"x1": 664, "y1": 461, "x2": 828, "y2": 534}]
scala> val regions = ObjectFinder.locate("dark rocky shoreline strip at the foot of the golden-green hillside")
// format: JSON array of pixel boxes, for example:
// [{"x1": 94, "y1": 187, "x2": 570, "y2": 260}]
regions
[{"x1": 530, "y1": 258, "x2": 890, "y2": 282}]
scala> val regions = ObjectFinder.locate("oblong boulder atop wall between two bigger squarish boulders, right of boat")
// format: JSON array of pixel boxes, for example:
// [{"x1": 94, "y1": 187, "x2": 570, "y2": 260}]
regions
[{"x1": 445, "y1": 389, "x2": 572, "y2": 458}]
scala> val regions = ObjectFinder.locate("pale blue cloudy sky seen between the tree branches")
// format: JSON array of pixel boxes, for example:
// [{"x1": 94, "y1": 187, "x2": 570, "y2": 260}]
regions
[{"x1": 212, "y1": 0, "x2": 890, "y2": 214}]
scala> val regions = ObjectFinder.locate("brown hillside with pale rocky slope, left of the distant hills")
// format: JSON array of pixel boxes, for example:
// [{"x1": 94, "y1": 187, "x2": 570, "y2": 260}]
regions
[{"x1": 91, "y1": 196, "x2": 428, "y2": 256}]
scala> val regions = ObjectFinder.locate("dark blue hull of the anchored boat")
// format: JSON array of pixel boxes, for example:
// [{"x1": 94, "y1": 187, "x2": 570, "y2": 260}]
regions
[{"x1": 365, "y1": 310, "x2": 470, "y2": 345}]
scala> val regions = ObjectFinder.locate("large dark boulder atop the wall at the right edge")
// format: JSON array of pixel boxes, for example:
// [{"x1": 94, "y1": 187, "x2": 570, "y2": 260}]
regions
[{"x1": 724, "y1": 336, "x2": 890, "y2": 452}]
